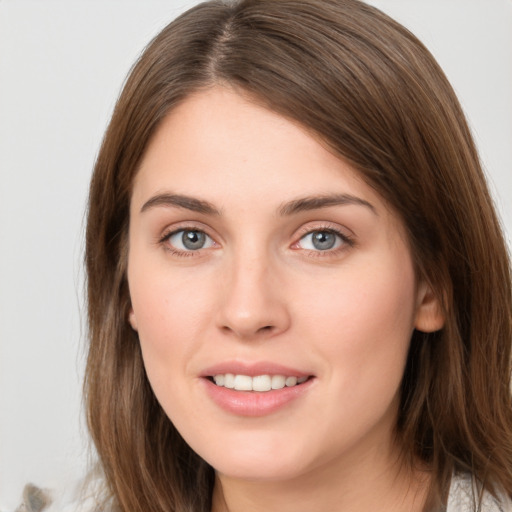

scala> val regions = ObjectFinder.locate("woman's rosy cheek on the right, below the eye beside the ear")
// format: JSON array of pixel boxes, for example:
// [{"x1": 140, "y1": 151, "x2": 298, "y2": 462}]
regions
[{"x1": 297, "y1": 253, "x2": 415, "y2": 381}]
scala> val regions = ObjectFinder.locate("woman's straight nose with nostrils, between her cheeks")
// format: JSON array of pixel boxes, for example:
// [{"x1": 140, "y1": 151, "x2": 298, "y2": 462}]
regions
[{"x1": 217, "y1": 249, "x2": 290, "y2": 340}]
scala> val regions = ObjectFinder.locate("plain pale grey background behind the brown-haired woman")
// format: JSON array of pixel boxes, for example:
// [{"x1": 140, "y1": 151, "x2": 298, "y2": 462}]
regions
[{"x1": 0, "y1": 0, "x2": 512, "y2": 511}]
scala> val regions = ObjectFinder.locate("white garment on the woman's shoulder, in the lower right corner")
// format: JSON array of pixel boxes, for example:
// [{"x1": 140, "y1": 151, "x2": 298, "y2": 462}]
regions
[{"x1": 446, "y1": 473, "x2": 512, "y2": 512}]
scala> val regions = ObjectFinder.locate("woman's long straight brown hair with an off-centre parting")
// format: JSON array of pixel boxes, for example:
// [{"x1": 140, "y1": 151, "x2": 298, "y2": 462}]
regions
[{"x1": 85, "y1": 0, "x2": 512, "y2": 512}]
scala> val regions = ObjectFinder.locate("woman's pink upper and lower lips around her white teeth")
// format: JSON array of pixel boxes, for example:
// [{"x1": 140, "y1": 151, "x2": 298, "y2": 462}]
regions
[{"x1": 200, "y1": 361, "x2": 316, "y2": 417}]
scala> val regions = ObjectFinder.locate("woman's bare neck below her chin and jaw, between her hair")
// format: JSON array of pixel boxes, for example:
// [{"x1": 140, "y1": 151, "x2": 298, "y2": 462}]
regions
[{"x1": 212, "y1": 444, "x2": 430, "y2": 512}]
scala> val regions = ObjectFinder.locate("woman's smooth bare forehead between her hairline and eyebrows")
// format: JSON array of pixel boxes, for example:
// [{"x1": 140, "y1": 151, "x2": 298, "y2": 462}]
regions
[{"x1": 134, "y1": 87, "x2": 376, "y2": 210}]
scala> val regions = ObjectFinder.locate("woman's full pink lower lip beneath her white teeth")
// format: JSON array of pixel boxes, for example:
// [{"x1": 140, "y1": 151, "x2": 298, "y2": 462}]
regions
[{"x1": 202, "y1": 378, "x2": 314, "y2": 417}]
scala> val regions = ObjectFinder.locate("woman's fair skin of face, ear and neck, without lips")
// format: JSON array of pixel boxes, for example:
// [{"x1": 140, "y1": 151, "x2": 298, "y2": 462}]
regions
[{"x1": 128, "y1": 87, "x2": 443, "y2": 512}]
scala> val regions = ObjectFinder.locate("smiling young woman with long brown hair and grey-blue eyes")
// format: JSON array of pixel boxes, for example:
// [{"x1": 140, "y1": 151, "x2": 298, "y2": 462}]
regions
[{"x1": 18, "y1": 0, "x2": 512, "y2": 512}]
